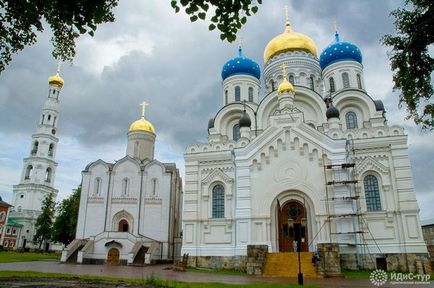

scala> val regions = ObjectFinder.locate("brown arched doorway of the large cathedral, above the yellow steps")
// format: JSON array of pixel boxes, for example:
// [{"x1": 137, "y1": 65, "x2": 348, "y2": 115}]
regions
[{"x1": 276, "y1": 200, "x2": 309, "y2": 252}]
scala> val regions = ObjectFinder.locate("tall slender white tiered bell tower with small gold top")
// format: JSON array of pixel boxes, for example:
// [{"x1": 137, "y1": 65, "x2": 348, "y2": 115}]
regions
[{"x1": 9, "y1": 69, "x2": 64, "y2": 249}]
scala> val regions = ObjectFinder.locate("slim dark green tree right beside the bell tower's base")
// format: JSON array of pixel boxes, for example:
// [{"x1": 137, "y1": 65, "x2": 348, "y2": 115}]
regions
[{"x1": 33, "y1": 193, "x2": 55, "y2": 249}]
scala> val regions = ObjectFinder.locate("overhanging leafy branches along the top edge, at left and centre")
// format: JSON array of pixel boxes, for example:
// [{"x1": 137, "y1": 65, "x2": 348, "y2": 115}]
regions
[{"x1": 0, "y1": 0, "x2": 262, "y2": 73}]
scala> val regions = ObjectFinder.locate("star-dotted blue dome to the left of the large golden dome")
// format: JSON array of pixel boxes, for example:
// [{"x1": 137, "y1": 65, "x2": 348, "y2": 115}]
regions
[{"x1": 222, "y1": 47, "x2": 261, "y2": 80}]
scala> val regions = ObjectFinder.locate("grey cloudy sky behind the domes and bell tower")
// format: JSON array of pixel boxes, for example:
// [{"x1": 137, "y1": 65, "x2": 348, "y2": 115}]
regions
[{"x1": 0, "y1": 0, "x2": 434, "y2": 219}]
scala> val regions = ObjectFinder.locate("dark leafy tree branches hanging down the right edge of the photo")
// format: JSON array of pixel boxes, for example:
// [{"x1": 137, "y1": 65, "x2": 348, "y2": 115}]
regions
[{"x1": 382, "y1": 0, "x2": 434, "y2": 129}]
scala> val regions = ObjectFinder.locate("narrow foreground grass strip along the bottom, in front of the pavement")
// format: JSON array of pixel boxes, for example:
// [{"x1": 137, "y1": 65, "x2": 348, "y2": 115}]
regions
[{"x1": 0, "y1": 271, "x2": 318, "y2": 288}]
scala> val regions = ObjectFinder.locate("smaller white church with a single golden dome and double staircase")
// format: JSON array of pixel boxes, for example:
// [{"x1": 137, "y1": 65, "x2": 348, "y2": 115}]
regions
[{"x1": 61, "y1": 103, "x2": 182, "y2": 265}]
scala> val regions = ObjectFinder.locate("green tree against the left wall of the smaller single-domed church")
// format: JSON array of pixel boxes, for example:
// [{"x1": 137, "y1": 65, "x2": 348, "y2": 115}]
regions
[{"x1": 51, "y1": 186, "x2": 81, "y2": 246}]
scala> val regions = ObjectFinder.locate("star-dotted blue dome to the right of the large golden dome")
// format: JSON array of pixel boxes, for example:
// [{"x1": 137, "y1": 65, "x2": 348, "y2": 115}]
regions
[{"x1": 319, "y1": 32, "x2": 362, "y2": 70}]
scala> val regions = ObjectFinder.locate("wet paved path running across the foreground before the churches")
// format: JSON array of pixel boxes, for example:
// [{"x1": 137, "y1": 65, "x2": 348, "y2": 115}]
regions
[{"x1": 0, "y1": 261, "x2": 434, "y2": 288}]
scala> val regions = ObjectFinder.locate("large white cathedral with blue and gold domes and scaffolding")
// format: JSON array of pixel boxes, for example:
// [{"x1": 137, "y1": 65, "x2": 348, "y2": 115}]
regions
[{"x1": 182, "y1": 16, "x2": 427, "y2": 270}]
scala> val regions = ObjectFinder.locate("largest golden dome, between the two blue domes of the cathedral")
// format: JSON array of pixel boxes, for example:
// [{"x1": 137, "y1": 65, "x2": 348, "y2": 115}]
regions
[{"x1": 264, "y1": 21, "x2": 317, "y2": 63}]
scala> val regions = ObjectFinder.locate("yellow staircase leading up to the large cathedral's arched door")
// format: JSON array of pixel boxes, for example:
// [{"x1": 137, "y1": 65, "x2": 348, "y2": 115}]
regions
[{"x1": 262, "y1": 252, "x2": 318, "y2": 278}]
